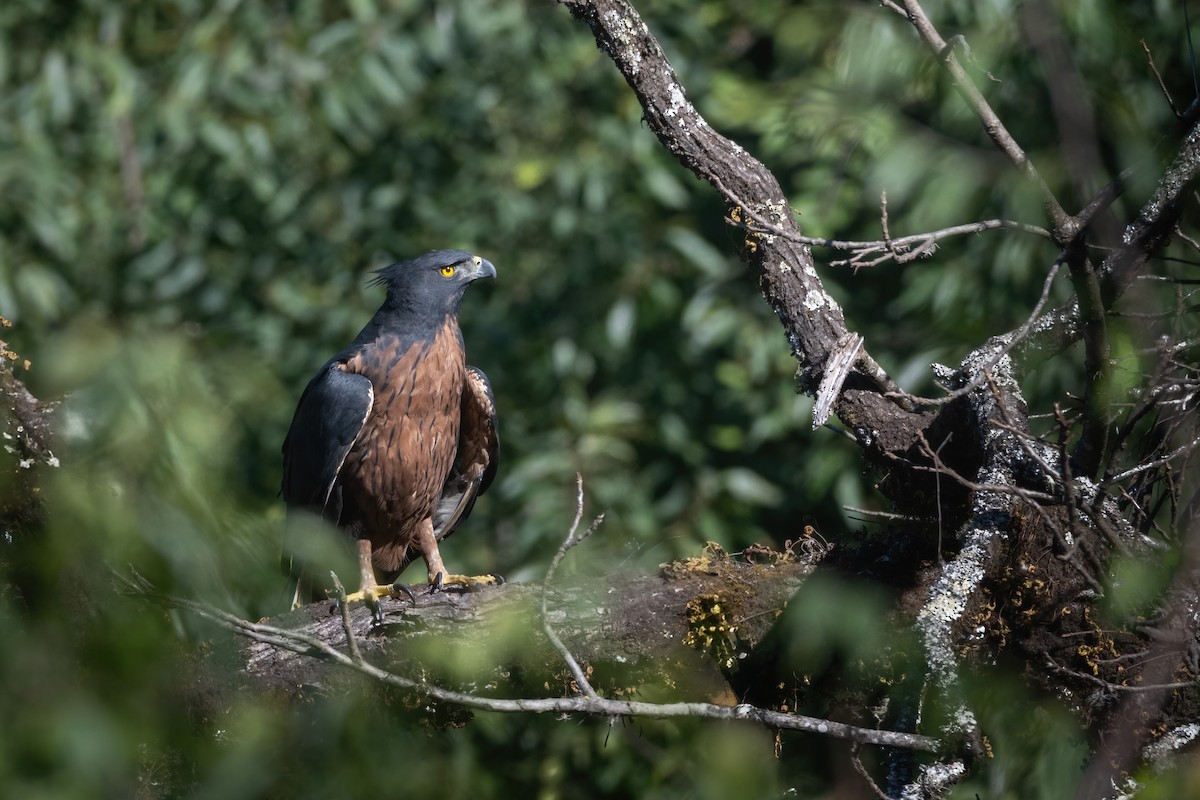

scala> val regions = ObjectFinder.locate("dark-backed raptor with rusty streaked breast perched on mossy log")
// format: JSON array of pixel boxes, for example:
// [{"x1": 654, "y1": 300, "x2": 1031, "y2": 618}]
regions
[{"x1": 282, "y1": 249, "x2": 499, "y2": 609}]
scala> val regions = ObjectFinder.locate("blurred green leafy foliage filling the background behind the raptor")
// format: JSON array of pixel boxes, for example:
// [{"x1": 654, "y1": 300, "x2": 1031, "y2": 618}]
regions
[{"x1": 0, "y1": 0, "x2": 1190, "y2": 799}]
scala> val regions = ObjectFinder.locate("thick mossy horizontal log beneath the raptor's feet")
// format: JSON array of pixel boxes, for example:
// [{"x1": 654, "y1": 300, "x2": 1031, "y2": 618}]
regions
[{"x1": 232, "y1": 543, "x2": 823, "y2": 705}]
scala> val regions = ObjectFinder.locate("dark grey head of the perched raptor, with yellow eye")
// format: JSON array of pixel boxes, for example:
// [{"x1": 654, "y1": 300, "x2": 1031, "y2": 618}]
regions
[{"x1": 371, "y1": 249, "x2": 496, "y2": 314}]
